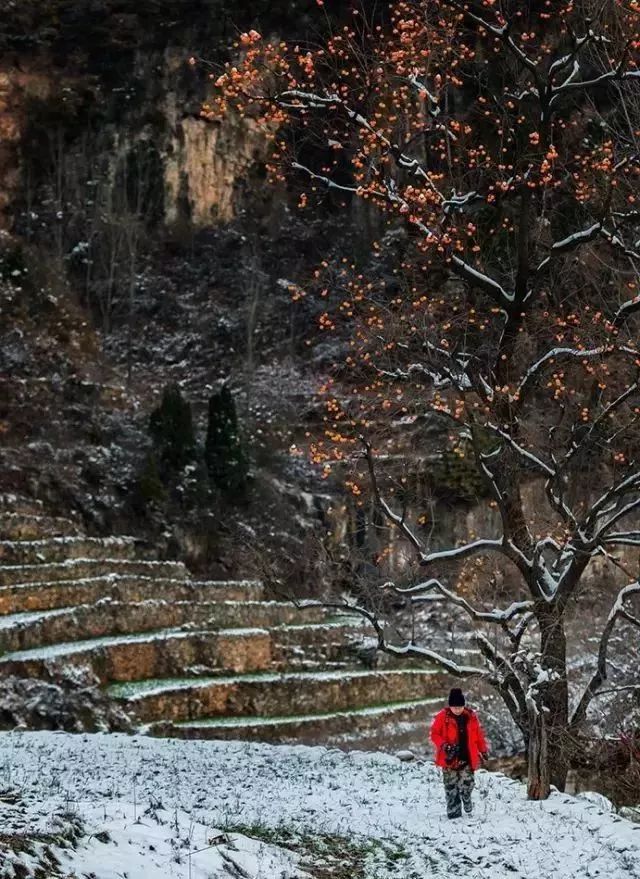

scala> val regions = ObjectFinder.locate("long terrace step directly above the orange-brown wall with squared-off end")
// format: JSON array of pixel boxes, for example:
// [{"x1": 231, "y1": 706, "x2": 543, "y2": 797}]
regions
[{"x1": 0, "y1": 599, "x2": 326, "y2": 654}]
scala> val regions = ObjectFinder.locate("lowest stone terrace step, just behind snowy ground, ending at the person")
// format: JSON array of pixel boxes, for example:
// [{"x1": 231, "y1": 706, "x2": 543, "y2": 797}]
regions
[{"x1": 150, "y1": 696, "x2": 443, "y2": 750}]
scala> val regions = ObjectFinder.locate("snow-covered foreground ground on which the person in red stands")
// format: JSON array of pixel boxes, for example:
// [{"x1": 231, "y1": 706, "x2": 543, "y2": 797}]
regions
[{"x1": 0, "y1": 732, "x2": 640, "y2": 879}]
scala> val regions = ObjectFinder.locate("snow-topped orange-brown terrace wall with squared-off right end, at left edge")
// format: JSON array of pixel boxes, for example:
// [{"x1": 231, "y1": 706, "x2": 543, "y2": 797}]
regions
[{"x1": 0, "y1": 628, "x2": 272, "y2": 683}]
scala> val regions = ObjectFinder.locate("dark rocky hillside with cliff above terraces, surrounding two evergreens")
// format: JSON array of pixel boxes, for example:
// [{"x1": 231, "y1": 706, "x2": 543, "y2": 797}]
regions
[{"x1": 0, "y1": 0, "x2": 372, "y2": 581}]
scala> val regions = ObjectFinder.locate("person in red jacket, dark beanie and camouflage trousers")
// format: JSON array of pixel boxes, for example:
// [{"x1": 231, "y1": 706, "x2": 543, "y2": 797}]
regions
[{"x1": 431, "y1": 687, "x2": 489, "y2": 818}]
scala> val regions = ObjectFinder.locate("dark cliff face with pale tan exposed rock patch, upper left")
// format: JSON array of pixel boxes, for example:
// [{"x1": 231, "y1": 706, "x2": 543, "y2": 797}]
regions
[{"x1": 0, "y1": 0, "x2": 348, "y2": 237}]
